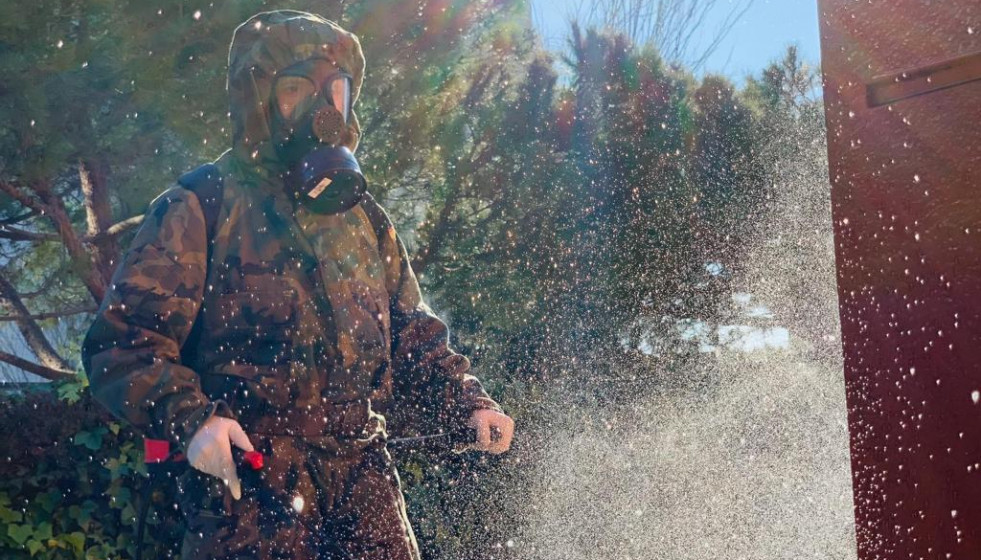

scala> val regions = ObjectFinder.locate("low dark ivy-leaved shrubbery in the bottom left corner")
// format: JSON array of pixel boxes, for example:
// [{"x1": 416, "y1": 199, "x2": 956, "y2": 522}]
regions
[{"x1": 0, "y1": 390, "x2": 178, "y2": 560}]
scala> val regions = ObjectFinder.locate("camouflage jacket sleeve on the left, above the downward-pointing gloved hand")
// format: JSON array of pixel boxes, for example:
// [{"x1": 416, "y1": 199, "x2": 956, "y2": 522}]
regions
[{"x1": 82, "y1": 186, "x2": 234, "y2": 451}]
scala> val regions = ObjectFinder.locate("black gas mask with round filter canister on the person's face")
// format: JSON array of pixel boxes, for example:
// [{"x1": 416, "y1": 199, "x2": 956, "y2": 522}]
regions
[{"x1": 271, "y1": 59, "x2": 368, "y2": 214}]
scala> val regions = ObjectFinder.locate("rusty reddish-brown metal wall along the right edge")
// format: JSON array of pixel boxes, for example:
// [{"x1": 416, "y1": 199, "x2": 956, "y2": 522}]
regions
[{"x1": 818, "y1": 0, "x2": 981, "y2": 560}]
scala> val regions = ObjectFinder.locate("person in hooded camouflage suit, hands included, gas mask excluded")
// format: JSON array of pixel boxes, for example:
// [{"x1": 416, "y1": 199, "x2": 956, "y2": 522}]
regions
[{"x1": 82, "y1": 11, "x2": 513, "y2": 560}]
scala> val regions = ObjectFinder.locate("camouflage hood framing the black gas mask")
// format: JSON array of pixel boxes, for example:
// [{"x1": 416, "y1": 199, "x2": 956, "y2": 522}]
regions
[{"x1": 227, "y1": 10, "x2": 365, "y2": 171}]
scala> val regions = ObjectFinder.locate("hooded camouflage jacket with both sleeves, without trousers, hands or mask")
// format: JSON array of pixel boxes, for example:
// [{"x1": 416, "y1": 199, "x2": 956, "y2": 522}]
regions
[{"x1": 82, "y1": 11, "x2": 499, "y2": 449}]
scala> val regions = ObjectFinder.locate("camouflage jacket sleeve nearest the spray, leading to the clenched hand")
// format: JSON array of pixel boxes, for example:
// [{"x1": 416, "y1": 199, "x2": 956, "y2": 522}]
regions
[{"x1": 379, "y1": 208, "x2": 501, "y2": 429}]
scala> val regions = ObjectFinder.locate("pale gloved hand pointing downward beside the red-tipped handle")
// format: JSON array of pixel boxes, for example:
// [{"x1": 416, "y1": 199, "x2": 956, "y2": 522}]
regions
[{"x1": 187, "y1": 416, "x2": 255, "y2": 500}]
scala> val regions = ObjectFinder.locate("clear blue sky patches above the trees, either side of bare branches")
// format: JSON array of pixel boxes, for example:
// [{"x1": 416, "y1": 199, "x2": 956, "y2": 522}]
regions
[{"x1": 530, "y1": 0, "x2": 821, "y2": 83}]
